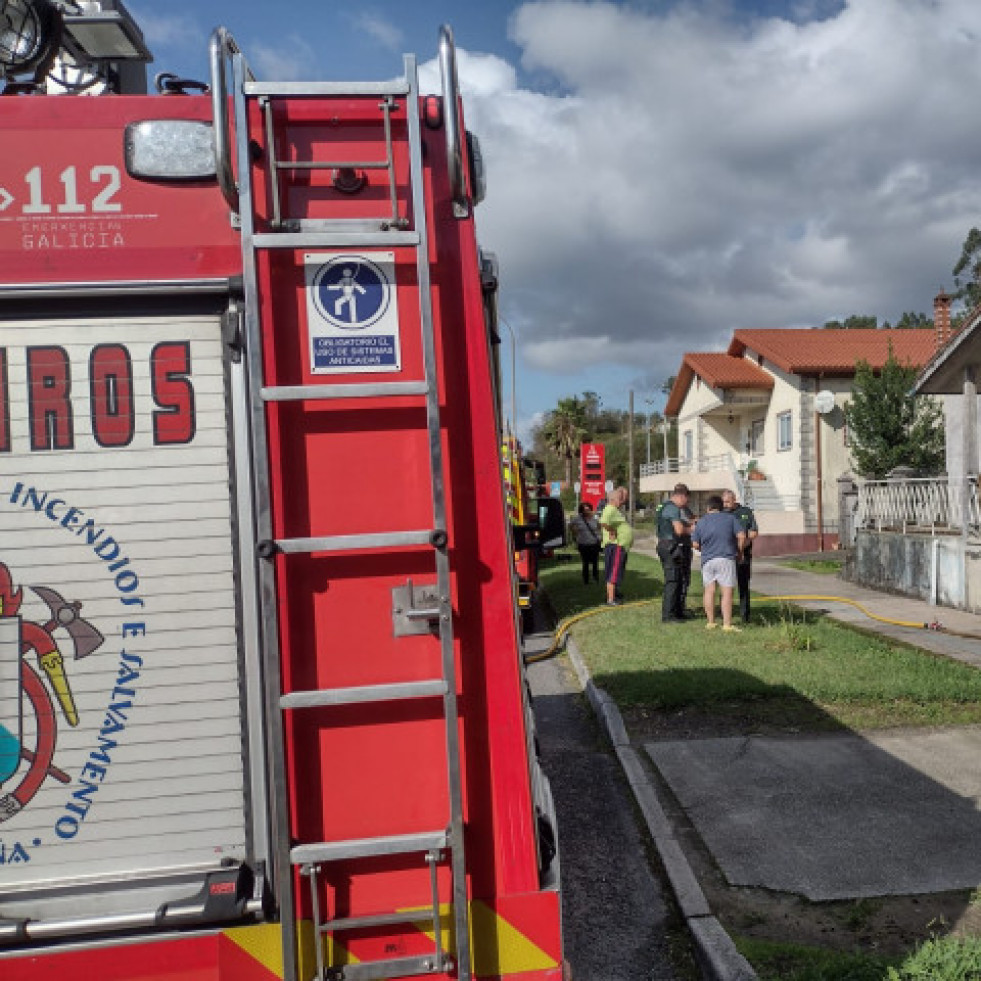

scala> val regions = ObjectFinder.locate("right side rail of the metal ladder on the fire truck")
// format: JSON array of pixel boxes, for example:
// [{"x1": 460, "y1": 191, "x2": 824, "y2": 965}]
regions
[{"x1": 405, "y1": 55, "x2": 471, "y2": 981}]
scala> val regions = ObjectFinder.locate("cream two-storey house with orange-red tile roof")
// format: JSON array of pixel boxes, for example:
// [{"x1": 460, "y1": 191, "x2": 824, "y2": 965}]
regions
[{"x1": 640, "y1": 329, "x2": 937, "y2": 555}]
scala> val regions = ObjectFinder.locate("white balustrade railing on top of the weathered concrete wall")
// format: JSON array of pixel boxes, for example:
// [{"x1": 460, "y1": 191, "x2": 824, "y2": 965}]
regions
[{"x1": 855, "y1": 477, "x2": 981, "y2": 534}]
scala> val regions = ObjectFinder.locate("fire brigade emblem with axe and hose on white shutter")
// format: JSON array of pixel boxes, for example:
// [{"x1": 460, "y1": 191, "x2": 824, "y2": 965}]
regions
[{"x1": 0, "y1": 562, "x2": 104, "y2": 822}]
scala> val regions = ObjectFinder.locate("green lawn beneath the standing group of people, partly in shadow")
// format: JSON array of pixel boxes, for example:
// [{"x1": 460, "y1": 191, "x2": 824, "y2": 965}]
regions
[{"x1": 542, "y1": 553, "x2": 981, "y2": 729}]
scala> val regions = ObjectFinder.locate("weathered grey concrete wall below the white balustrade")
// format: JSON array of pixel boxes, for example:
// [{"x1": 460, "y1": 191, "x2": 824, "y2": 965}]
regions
[{"x1": 842, "y1": 530, "x2": 981, "y2": 613}]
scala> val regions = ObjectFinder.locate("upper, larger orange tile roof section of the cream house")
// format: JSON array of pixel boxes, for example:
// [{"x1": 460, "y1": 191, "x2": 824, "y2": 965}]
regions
[{"x1": 729, "y1": 328, "x2": 937, "y2": 376}]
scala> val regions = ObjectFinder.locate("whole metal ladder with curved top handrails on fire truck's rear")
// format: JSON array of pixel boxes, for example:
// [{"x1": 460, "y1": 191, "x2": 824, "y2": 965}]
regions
[{"x1": 211, "y1": 27, "x2": 472, "y2": 981}]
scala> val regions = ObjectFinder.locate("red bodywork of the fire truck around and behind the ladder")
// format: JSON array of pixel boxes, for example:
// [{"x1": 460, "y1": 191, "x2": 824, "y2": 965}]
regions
[{"x1": 0, "y1": 32, "x2": 562, "y2": 981}]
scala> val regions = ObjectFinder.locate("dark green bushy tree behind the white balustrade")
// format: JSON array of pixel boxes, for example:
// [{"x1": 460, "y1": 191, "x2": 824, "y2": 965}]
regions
[{"x1": 845, "y1": 346, "x2": 944, "y2": 480}]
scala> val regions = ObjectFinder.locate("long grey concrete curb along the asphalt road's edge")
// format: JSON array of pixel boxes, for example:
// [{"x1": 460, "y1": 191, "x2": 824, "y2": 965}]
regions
[{"x1": 566, "y1": 637, "x2": 758, "y2": 981}]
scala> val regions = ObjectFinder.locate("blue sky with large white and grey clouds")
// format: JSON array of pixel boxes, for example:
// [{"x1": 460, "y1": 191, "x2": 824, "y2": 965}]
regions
[{"x1": 127, "y1": 0, "x2": 981, "y2": 436}]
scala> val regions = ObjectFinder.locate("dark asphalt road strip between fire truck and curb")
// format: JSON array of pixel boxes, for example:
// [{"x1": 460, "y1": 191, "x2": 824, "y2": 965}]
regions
[{"x1": 528, "y1": 645, "x2": 699, "y2": 981}]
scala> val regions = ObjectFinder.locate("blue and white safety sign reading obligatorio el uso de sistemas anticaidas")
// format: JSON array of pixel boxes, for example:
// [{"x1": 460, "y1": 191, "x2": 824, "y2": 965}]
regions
[{"x1": 305, "y1": 252, "x2": 402, "y2": 374}]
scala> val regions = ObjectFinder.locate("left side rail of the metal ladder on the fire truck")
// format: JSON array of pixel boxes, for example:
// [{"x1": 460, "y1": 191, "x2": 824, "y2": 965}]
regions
[{"x1": 232, "y1": 52, "x2": 299, "y2": 981}]
